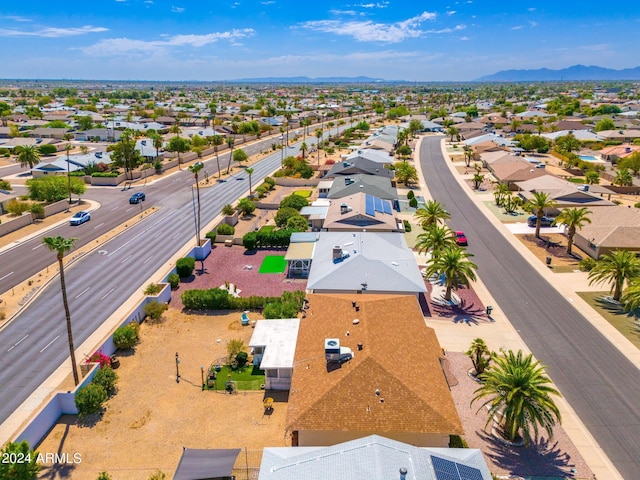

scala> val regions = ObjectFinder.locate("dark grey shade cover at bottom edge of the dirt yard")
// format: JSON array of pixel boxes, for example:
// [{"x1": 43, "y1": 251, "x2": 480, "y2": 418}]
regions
[{"x1": 173, "y1": 447, "x2": 240, "y2": 480}]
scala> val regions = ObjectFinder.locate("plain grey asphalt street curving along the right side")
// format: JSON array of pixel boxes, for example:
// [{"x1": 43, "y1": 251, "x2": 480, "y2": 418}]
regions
[{"x1": 420, "y1": 137, "x2": 640, "y2": 478}]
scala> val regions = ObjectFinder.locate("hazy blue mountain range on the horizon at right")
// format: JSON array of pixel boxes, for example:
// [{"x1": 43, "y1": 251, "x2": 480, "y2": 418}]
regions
[{"x1": 474, "y1": 65, "x2": 640, "y2": 82}]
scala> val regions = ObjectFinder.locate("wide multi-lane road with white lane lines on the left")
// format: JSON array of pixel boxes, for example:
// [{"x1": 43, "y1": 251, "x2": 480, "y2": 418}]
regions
[{"x1": 0, "y1": 133, "x2": 306, "y2": 423}]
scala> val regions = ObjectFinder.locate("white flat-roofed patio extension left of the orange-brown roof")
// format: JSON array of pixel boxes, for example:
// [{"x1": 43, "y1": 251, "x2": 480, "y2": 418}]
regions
[{"x1": 249, "y1": 318, "x2": 300, "y2": 390}]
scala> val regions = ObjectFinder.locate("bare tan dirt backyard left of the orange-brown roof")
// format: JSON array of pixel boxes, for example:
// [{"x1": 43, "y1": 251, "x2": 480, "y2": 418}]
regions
[{"x1": 37, "y1": 309, "x2": 289, "y2": 480}]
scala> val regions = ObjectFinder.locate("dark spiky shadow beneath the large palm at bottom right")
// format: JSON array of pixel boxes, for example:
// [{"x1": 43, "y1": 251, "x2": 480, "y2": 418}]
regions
[{"x1": 476, "y1": 431, "x2": 576, "y2": 478}]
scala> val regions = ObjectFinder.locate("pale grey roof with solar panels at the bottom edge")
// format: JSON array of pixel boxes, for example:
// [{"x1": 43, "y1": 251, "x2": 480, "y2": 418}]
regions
[{"x1": 258, "y1": 435, "x2": 493, "y2": 480}]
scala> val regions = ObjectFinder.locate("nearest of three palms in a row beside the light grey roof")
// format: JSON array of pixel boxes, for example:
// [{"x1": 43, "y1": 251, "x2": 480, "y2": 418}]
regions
[{"x1": 427, "y1": 246, "x2": 478, "y2": 301}]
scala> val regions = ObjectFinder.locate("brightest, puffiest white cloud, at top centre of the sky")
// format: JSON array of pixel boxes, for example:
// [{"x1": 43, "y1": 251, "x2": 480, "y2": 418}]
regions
[{"x1": 301, "y1": 12, "x2": 436, "y2": 43}]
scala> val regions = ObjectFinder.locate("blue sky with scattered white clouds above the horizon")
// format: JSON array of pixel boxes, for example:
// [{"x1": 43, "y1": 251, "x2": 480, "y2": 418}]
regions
[{"x1": 0, "y1": 0, "x2": 640, "y2": 81}]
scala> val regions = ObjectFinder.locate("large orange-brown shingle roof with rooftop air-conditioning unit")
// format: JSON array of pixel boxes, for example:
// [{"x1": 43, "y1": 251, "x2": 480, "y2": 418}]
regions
[{"x1": 286, "y1": 294, "x2": 463, "y2": 434}]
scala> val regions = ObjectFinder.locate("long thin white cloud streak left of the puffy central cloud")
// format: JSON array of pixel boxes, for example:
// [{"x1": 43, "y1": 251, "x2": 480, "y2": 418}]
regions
[{"x1": 81, "y1": 28, "x2": 255, "y2": 57}]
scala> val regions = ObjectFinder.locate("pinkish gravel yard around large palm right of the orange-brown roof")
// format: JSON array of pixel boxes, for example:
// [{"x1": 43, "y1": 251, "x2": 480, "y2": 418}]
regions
[{"x1": 447, "y1": 352, "x2": 593, "y2": 479}]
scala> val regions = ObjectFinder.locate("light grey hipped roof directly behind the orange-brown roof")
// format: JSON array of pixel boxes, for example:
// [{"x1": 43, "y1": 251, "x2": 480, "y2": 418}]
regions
[{"x1": 307, "y1": 231, "x2": 427, "y2": 297}]
